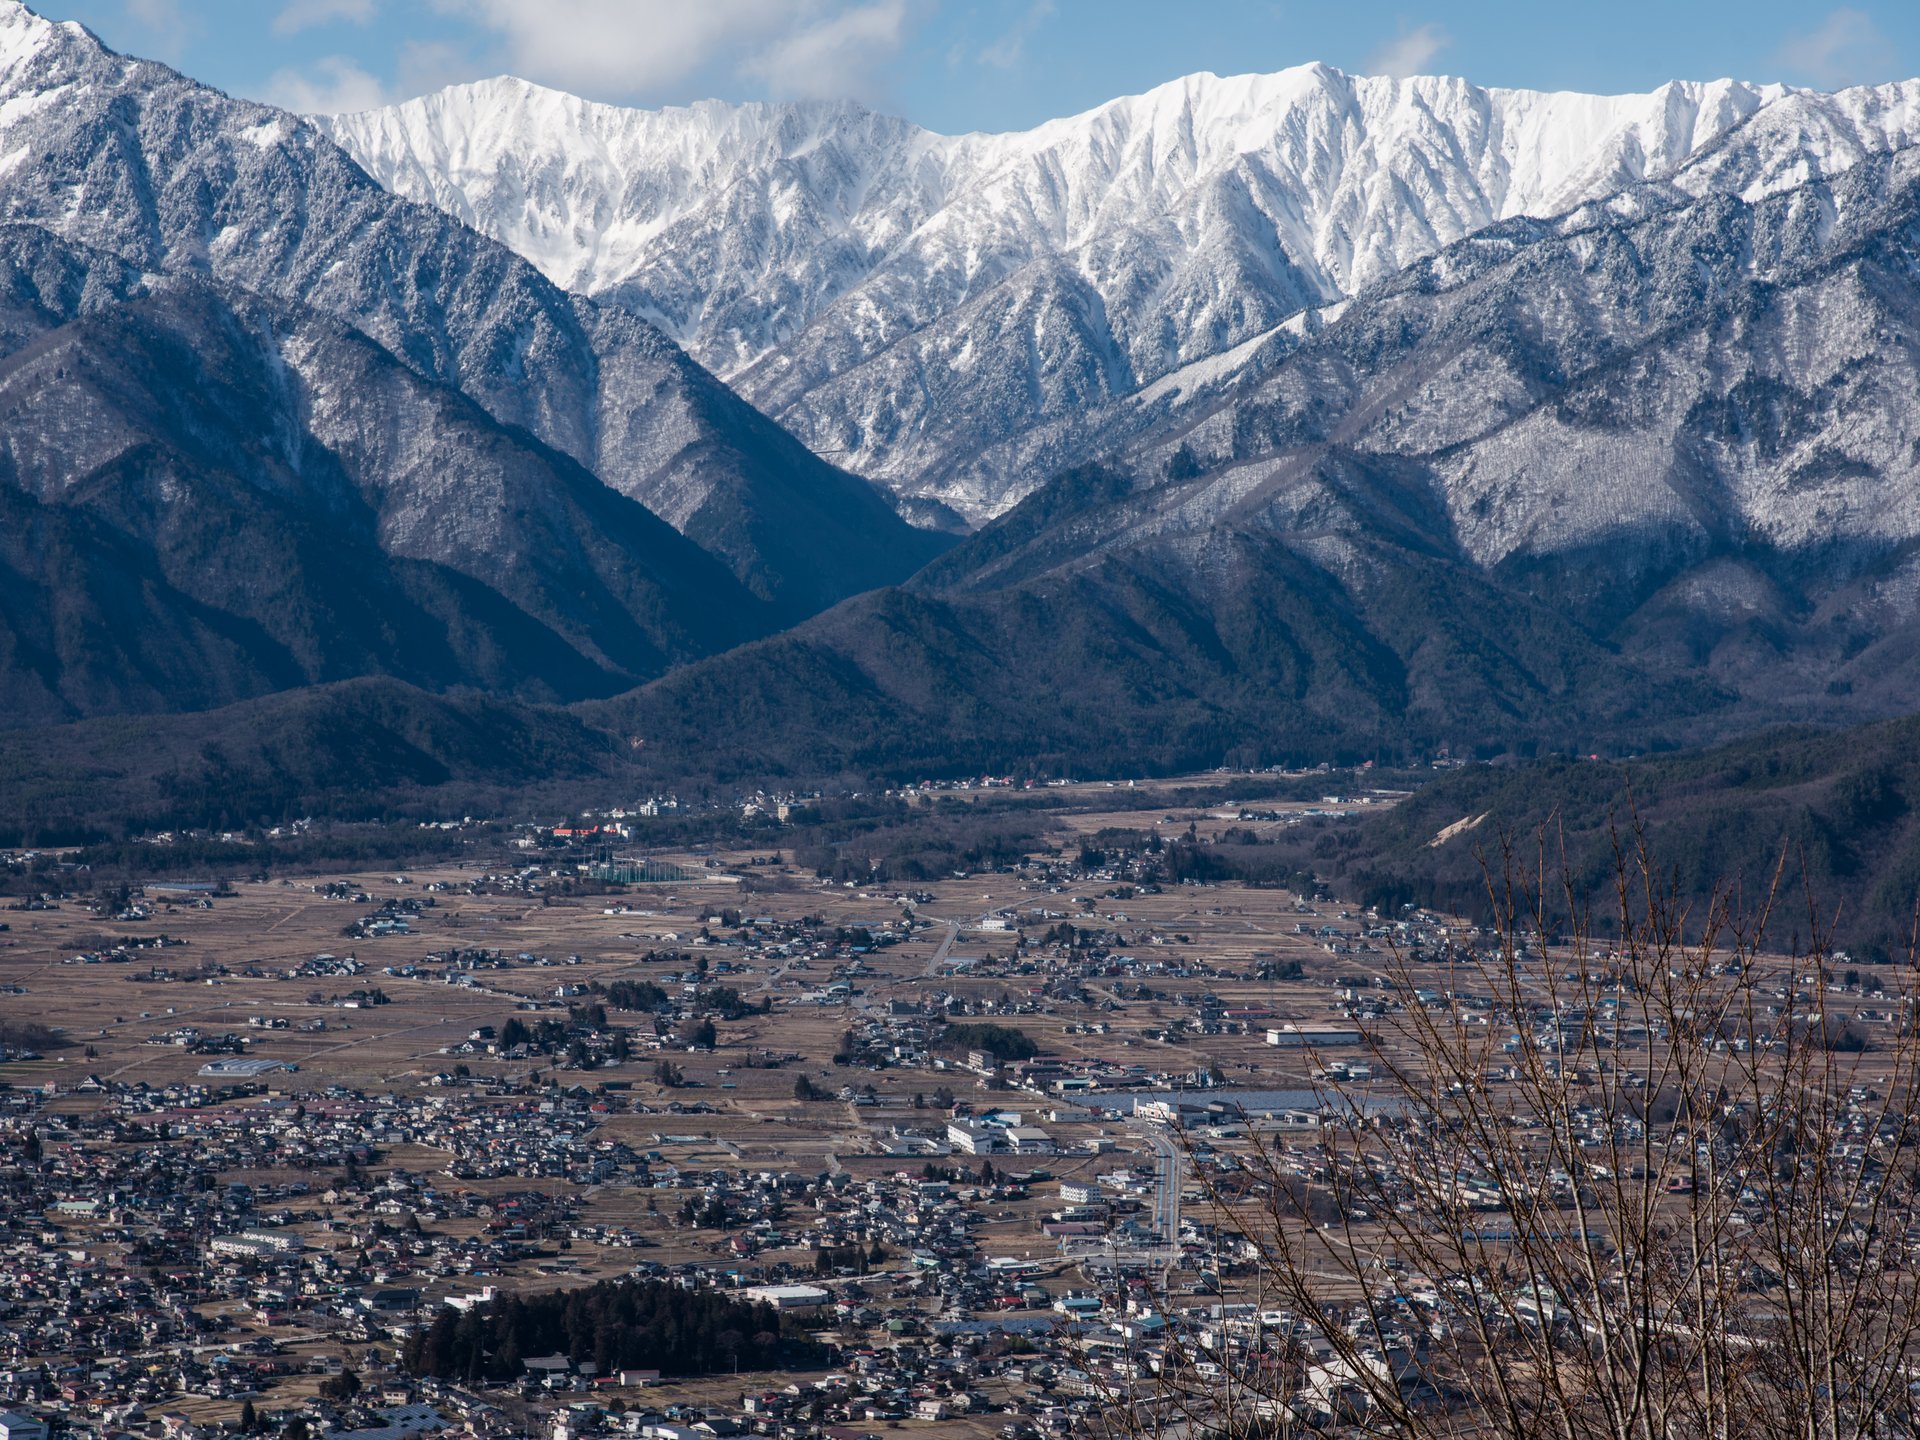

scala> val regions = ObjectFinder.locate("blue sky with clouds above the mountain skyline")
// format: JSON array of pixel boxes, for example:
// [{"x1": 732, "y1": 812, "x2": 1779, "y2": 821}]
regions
[{"x1": 31, "y1": 0, "x2": 1920, "y2": 131}]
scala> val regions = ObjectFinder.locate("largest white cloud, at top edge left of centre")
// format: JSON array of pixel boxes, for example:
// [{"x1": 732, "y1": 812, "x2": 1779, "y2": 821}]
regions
[{"x1": 434, "y1": 0, "x2": 908, "y2": 98}]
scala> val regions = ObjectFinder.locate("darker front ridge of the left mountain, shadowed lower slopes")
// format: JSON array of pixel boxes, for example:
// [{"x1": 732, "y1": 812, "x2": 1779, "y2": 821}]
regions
[{"x1": 0, "y1": 225, "x2": 774, "y2": 722}]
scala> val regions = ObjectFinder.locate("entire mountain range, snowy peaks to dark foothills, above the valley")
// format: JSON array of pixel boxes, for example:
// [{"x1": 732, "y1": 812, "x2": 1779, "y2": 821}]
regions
[{"x1": 0, "y1": 0, "x2": 1920, "y2": 824}]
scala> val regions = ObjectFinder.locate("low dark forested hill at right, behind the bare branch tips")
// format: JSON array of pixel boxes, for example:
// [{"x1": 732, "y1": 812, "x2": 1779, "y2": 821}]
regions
[{"x1": 1244, "y1": 718, "x2": 1920, "y2": 960}]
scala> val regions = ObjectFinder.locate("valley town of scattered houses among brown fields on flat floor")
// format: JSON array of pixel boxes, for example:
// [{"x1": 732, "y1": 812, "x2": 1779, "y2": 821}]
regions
[{"x1": 0, "y1": 787, "x2": 1471, "y2": 1440}]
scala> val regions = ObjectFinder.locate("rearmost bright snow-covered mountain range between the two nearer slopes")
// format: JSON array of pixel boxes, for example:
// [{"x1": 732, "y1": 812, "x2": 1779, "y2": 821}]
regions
[{"x1": 319, "y1": 65, "x2": 1920, "y2": 520}]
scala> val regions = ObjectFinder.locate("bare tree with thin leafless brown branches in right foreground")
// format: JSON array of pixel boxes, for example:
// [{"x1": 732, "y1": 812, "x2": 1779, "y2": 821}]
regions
[{"x1": 1106, "y1": 831, "x2": 1920, "y2": 1440}]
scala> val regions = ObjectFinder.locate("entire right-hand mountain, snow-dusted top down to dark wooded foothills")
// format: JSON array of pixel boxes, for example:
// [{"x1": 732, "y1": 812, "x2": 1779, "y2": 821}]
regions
[{"x1": 609, "y1": 148, "x2": 1920, "y2": 783}]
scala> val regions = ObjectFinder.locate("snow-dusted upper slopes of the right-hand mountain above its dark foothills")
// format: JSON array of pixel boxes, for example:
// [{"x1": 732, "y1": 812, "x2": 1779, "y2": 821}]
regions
[{"x1": 1131, "y1": 150, "x2": 1920, "y2": 685}]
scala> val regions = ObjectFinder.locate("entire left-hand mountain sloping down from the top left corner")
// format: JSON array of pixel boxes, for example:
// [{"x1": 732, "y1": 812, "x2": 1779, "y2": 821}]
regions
[{"x1": 0, "y1": 0, "x2": 943, "y2": 720}]
